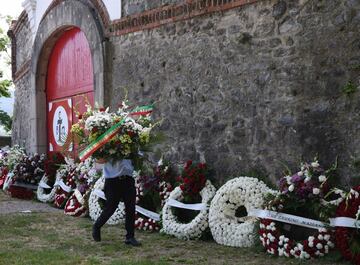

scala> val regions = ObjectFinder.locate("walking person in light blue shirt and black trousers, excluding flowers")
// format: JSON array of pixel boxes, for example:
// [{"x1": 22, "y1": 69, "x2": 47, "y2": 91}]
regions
[{"x1": 92, "y1": 159, "x2": 141, "y2": 246}]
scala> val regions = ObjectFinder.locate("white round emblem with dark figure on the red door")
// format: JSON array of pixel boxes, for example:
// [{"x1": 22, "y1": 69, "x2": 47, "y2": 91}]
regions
[{"x1": 53, "y1": 106, "x2": 69, "y2": 146}]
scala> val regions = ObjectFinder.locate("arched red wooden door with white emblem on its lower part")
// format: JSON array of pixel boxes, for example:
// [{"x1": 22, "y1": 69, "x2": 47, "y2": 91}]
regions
[{"x1": 46, "y1": 28, "x2": 94, "y2": 153}]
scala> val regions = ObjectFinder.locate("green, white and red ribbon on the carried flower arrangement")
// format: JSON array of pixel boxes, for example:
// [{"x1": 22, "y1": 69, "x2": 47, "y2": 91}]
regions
[{"x1": 79, "y1": 105, "x2": 154, "y2": 162}]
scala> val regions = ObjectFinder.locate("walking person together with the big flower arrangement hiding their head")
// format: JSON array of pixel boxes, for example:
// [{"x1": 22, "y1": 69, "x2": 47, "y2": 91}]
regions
[{"x1": 71, "y1": 101, "x2": 153, "y2": 246}]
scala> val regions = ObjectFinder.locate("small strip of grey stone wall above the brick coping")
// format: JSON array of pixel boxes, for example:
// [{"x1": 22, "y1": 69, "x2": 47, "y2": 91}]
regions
[{"x1": 121, "y1": 0, "x2": 185, "y2": 17}]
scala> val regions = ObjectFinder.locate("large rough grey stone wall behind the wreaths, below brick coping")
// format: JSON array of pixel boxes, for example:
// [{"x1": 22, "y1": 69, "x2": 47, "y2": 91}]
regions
[{"x1": 108, "y1": 0, "x2": 360, "y2": 182}]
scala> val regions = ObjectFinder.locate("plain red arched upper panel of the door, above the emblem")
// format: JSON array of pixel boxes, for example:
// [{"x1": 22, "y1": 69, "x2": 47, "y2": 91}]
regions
[{"x1": 46, "y1": 28, "x2": 93, "y2": 101}]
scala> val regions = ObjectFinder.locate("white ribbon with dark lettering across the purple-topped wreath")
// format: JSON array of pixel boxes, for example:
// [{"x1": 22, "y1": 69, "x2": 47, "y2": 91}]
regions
[{"x1": 248, "y1": 209, "x2": 326, "y2": 229}]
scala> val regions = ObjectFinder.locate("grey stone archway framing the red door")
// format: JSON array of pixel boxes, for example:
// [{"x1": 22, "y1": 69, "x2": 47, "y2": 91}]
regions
[{"x1": 29, "y1": 1, "x2": 105, "y2": 153}]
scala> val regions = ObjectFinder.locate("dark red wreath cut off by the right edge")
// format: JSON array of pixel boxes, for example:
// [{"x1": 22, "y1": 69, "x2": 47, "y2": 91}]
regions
[{"x1": 335, "y1": 186, "x2": 360, "y2": 264}]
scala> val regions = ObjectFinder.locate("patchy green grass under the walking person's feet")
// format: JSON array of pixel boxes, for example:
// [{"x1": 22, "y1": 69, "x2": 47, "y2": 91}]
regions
[{"x1": 0, "y1": 192, "x2": 343, "y2": 265}]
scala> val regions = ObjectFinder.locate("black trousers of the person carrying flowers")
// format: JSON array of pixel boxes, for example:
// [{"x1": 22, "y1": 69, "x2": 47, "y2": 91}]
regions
[{"x1": 95, "y1": 176, "x2": 136, "y2": 239}]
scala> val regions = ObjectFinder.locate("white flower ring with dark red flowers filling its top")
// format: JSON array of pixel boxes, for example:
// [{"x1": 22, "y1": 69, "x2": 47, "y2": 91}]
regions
[{"x1": 161, "y1": 180, "x2": 216, "y2": 240}]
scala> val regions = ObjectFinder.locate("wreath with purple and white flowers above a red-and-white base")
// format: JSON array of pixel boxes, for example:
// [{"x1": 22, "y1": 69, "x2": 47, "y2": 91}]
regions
[{"x1": 259, "y1": 161, "x2": 334, "y2": 259}]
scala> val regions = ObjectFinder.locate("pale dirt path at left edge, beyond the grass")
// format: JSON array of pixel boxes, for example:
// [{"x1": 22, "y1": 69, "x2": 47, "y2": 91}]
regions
[{"x1": 0, "y1": 190, "x2": 61, "y2": 214}]
